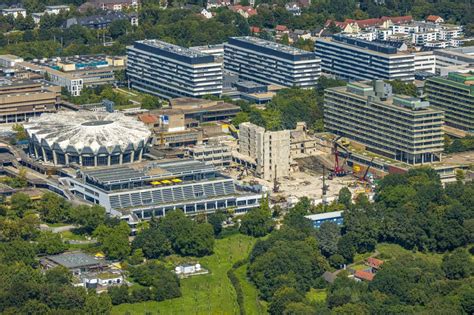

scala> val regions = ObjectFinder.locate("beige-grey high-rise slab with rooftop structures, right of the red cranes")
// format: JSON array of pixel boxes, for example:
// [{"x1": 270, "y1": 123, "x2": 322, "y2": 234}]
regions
[{"x1": 324, "y1": 81, "x2": 444, "y2": 164}]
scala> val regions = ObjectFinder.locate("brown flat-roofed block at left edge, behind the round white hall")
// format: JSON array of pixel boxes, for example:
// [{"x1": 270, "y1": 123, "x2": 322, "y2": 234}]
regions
[{"x1": 0, "y1": 81, "x2": 61, "y2": 123}]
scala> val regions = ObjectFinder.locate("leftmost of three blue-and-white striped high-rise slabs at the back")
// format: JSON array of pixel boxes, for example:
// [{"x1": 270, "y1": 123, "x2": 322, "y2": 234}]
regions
[{"x1": 127, "y1": 40, "x2": 222, "y2": 98}]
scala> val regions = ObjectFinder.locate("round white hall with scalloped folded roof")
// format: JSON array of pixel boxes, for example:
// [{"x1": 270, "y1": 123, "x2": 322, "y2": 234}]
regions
[{"x1": 25, "y1": 111, "x2": 151, "y2": 166}]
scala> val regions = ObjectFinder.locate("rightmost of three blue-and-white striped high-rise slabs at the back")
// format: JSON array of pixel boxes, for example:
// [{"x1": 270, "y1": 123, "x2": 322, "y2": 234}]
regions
[{"x1": 315, "y1": 34, "x2": 415, "y2": 81}]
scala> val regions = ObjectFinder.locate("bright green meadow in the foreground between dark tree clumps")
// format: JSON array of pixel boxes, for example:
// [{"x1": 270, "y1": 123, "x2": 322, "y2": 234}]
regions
[{"x1": 112, "y1": 234, "x2": 256, "y2": 315}]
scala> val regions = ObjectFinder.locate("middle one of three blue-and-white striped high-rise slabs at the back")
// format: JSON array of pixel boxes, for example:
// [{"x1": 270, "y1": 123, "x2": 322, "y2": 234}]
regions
[{"x1": 224, "y1": 36, "x2": 321, "y2": 88}]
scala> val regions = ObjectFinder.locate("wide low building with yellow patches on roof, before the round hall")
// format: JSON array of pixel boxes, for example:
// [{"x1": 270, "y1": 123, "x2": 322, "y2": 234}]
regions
[{"x1": 68, "y1": 160, "x2": 262, "y2": 219}]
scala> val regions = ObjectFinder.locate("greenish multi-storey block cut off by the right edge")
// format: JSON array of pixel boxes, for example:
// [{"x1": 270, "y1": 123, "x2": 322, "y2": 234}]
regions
[{"x1": 425, "y1": 72, "x2": 474, "y2": 133}]
